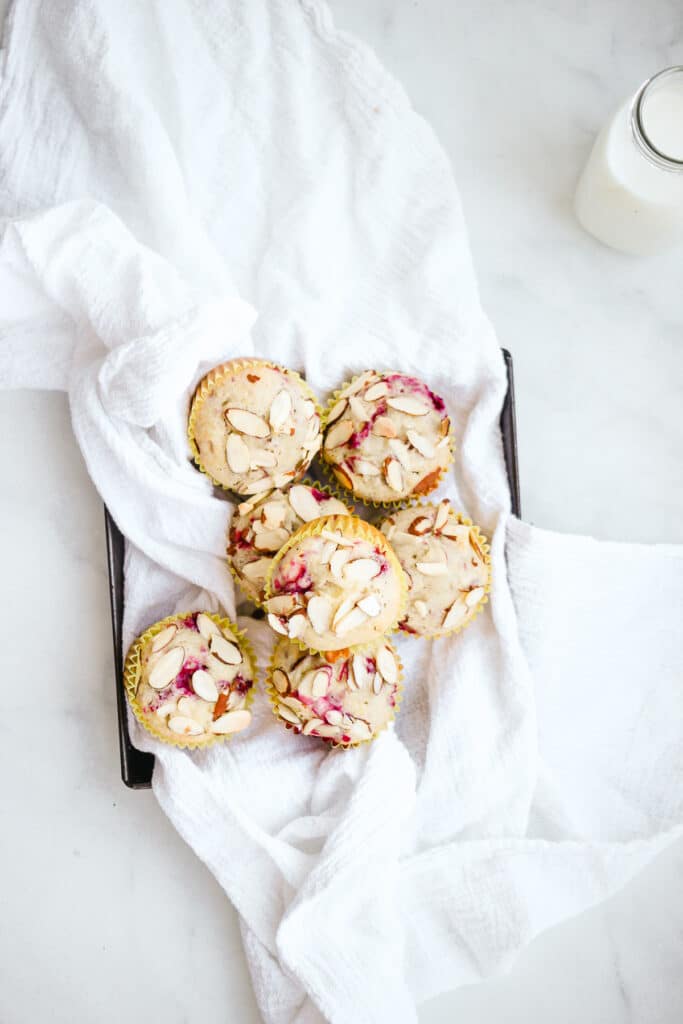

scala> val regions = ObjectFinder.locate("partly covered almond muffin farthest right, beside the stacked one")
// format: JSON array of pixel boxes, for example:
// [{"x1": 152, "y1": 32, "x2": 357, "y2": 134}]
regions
[{"x1": 381, "y1": 501, "x2": 490, "y2": 637}]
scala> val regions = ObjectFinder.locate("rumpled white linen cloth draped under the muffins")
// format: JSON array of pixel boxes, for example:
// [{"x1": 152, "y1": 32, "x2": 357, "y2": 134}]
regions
[{"x1": 0, "y1": 0, "x2": 683, "y2": 1024}]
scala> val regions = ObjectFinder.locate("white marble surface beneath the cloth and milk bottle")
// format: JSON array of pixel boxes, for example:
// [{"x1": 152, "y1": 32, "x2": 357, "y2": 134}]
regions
[{"x1": 0, "y1": 0, "x2": 683, "y2": 1024}]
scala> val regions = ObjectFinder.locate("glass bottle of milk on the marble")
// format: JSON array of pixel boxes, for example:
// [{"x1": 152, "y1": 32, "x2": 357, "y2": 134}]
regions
[{"x1": 574, "y1": 65, "x2": 683, "y2": 254}]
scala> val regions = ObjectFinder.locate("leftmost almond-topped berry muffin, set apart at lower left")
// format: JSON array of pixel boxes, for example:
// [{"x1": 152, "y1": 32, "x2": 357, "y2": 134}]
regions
[{"x1": 124, "y1": 611, "x2": 256, "y2": 746}]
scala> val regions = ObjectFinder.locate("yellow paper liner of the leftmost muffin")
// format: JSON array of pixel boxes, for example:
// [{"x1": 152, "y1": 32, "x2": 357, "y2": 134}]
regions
[{"x1": 123, "y1": 608, "x2": 258, "y2": 750}]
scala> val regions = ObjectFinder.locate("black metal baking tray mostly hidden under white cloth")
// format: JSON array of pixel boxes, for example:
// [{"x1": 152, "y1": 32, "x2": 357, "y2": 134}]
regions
[{"x1": 104, "y1": 348, "x2": 521, "y2": 790}]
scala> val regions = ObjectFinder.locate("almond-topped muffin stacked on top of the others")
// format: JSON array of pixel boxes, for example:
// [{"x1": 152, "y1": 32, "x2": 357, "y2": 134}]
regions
[{"x1": 265, "y1": 515, "x2": 405, "y2": 651}]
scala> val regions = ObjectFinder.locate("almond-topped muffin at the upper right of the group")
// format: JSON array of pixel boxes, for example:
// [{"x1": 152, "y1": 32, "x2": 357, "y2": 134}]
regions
[{"x1": 323, "y1": 370, "x2": 453, "y2": 503}]
